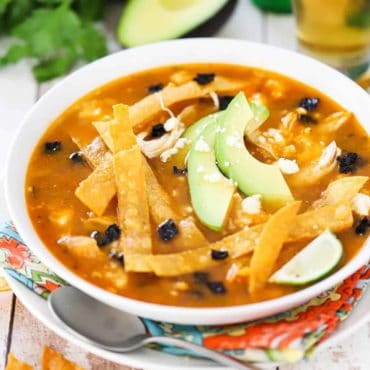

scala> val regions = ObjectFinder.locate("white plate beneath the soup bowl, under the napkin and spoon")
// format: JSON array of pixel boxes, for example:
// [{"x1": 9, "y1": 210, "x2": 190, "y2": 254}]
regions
[{"x1": 5, "y1": 274, "x2": 370, "y2": 370}]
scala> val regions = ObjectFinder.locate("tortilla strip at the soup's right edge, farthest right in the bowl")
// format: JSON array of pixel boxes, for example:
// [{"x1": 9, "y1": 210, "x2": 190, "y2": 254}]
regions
[{"x1": 310, "y1": 176, "x2": 369, "y2": 209}]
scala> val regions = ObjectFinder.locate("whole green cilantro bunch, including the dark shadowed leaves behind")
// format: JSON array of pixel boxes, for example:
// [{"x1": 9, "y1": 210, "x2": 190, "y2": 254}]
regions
[{"x1": 0, "y1": 0, "x2": 107, "y2": 82}]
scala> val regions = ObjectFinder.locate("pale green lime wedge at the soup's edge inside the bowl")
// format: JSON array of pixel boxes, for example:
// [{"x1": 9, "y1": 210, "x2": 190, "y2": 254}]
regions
[{"x1": 269, "y1": 230, "x2": 343, "y2": 285}]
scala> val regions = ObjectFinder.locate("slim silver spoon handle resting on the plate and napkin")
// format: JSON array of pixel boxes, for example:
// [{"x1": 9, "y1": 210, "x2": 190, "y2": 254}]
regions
[{"x1": 142, "y1": 337, "x2": 261, "y2": 370}]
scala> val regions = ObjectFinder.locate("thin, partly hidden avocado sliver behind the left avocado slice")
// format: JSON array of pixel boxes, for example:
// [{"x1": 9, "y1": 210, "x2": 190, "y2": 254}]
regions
[{"x1": 171, "y1": 112, "x2": 224, "y2": 167}]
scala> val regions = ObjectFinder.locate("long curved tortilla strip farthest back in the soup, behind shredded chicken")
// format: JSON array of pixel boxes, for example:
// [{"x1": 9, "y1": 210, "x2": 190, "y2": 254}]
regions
[{"x1": 129, "y1": 76, "x2": 245, "y2": 133}]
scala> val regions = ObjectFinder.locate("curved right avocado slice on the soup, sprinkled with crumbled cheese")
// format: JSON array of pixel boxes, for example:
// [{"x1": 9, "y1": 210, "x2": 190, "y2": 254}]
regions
[{"x1": 215, "y1": 93, "x2": 293, "y2": 208}]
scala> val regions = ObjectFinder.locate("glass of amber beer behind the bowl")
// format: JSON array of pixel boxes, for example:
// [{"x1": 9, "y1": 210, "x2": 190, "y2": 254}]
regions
[{"x1": 293, "y1": 0, "x2": 370, "y2": 78}]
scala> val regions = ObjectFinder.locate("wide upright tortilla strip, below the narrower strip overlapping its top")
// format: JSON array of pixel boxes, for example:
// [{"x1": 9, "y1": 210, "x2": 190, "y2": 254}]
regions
[{"x1": 113, "y1": 145, "x2": 152, "y2": 260}]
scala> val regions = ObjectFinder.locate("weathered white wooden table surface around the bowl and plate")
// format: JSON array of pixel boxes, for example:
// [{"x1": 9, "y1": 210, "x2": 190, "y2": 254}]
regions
[{"x1": 0, "y1": 0, "x2": 370, "y2": 370}]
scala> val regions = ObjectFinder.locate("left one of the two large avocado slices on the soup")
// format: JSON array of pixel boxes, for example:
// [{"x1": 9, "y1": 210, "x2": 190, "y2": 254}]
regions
[{"x1": 188, "y1": 122, "x2": 235, "y2": 231}]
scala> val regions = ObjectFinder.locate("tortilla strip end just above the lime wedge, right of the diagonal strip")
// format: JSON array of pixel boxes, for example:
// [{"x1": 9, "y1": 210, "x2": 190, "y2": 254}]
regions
[{"x1": 288, "y1": 203, "x2": 353, "y2": 242}]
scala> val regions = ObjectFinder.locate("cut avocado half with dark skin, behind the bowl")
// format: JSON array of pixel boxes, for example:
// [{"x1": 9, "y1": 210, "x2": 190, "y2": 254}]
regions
[{"x1": 117, "y1": 0, "x2": 237, "y2": 47}]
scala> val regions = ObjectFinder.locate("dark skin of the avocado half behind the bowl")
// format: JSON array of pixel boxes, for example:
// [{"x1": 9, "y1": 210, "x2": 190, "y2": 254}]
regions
[{"x1": 184, "y1": 0, "x2": 238, "y2": 38}]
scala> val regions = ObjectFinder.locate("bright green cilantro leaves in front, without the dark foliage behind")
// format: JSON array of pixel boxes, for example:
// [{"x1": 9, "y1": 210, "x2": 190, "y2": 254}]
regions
[{"x1": 0, "y1": 0, "x2": 107, "y2": 81}]
